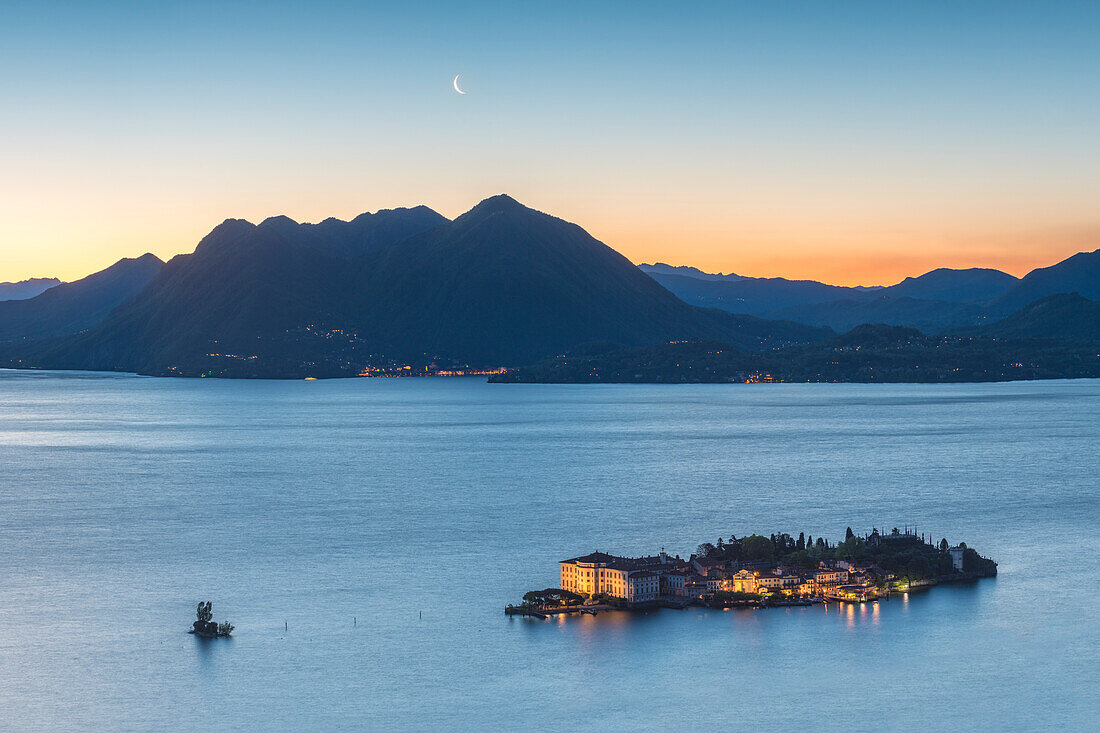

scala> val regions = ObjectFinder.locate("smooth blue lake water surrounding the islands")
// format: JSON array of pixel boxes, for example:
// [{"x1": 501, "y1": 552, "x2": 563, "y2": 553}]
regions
[{"x1": 0, "y1": 371, "x2": 1100, "y2": 731}]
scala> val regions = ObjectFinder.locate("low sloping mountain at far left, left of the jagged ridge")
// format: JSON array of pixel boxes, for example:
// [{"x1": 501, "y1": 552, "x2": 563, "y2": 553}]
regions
[{"x1": 0, "y1": 254, "x2": 164, "y2": 342}]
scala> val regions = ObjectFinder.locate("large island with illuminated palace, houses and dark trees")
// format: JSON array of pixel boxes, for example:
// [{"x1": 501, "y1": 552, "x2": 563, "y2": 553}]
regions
[{"x1": 505, "y1": 527, "x2": 997, "y2": 617}]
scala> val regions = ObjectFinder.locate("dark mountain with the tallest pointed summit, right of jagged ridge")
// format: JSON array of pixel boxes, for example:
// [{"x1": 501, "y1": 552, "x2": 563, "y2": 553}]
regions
[{"x1": 343, "y1": 195, "x2": 827, "y2": 364}]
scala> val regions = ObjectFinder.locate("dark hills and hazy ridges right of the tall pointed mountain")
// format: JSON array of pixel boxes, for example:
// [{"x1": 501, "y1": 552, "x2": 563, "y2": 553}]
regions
[{"x1": 499, "y1": 251, "x2": 1100, "y2": 384}]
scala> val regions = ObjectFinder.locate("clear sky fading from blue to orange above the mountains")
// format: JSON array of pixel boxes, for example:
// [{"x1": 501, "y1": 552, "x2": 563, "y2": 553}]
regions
[{"x1": 0, "y1": 0, "x2": 1100, "y2": 285}]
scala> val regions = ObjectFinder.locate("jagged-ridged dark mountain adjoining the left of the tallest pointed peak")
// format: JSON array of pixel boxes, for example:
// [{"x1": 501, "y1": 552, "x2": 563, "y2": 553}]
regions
[{"x1": 32, "y1": 207, "x2": 447, "y2": 376}]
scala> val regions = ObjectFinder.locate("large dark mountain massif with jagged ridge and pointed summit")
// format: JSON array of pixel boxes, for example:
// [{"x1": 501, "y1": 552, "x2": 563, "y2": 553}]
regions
[{"x1": 0, "y1": 196, "x2": 829, "y2": 376}]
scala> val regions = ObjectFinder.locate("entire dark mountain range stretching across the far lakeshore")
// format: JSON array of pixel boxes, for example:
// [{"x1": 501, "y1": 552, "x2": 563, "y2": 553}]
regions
[{"x1": 0, "y1": 195, "x2": 1100, "y2": 381}]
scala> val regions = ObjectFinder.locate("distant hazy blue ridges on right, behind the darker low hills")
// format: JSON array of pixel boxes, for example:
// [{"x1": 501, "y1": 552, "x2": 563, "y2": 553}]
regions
[{"x1": 639, "y1": 250, "x2": 1100, "y2": 333}]
